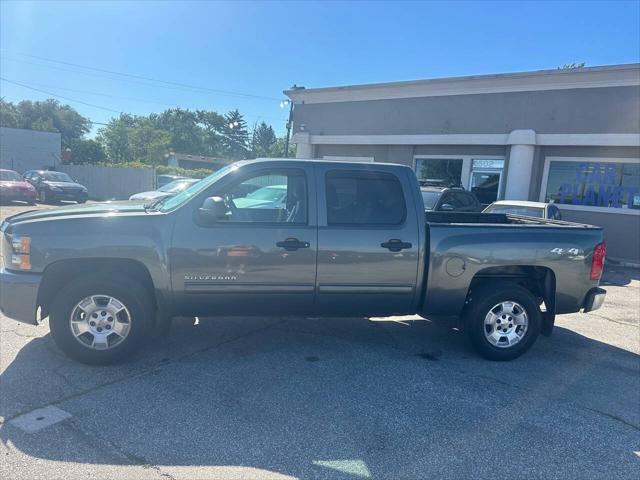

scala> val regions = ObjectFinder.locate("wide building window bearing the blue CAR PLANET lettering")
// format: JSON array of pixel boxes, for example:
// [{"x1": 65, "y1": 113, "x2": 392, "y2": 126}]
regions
[{"x1": 541, "y1": 158, "x2": 640, "y2": 210}]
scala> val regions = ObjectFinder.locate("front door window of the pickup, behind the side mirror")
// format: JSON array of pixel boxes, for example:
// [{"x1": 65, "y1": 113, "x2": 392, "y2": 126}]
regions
[{"x1": 224, "y1": 170, "x2": 308, "y2": 224}]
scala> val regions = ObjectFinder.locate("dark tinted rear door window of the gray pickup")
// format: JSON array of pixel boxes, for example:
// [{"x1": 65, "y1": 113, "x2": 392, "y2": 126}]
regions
[{"x1": 325, "y1": 170, "x2": 407, "y2": 225}]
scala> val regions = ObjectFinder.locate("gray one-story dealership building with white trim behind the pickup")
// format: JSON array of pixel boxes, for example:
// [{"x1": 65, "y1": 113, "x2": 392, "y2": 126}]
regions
[{"x1": 285, "y1": 64, "x2": 640, "y2": 264}]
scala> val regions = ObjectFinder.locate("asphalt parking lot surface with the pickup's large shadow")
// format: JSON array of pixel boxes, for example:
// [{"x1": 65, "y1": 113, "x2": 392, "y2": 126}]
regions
[{"x1": 0, "y1": 201, "x2": 640, "y2": 479}]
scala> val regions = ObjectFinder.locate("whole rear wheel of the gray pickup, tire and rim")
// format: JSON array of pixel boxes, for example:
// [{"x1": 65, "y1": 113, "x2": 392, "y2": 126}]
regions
[{"x1": 465, "y1": 282, "x2": 542, "y2": 361}]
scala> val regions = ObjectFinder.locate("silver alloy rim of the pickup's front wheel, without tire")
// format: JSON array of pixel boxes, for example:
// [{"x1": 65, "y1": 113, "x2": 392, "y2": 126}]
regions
[{"x1": 69, "y1": 295, "x2": 131, "y2": 350}]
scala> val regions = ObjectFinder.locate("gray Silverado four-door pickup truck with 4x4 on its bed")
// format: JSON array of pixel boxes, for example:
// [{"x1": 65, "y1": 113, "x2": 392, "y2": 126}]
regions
[{"x1": 0, "y1": 160, "x2": 605, "y2": 364}]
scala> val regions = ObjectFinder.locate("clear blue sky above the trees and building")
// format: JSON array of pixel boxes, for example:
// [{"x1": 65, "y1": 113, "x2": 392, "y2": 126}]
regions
[{"x1": 0, "y1": 0, "x2": 640, "y2": 134}]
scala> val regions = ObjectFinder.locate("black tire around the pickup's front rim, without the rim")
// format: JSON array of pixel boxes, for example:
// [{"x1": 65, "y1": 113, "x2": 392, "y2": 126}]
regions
[{"x1": 49, "y1": 275, "x2": 155, "y2": 365}]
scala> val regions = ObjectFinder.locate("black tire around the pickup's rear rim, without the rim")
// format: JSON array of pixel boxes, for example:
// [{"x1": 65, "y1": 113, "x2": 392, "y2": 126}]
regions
[{"x1": 464, "y1": 282, "x2": 542, "y2": 361}]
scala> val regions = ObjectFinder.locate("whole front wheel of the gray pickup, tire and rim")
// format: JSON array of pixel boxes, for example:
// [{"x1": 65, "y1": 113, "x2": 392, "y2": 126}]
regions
[{"x1": 49, "y1": 276, "x2": 154, "y2": 365}]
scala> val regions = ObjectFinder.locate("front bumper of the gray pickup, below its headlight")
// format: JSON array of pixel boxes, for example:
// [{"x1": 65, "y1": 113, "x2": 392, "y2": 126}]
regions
[{"x1": 0, "y1": 268, "x2": 42, "y2": 325}]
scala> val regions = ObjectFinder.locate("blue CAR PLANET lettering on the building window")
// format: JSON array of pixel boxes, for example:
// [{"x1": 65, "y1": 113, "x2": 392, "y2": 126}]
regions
[{"x1": 559, "y1": 163, "x2": 640, "y2": 208}]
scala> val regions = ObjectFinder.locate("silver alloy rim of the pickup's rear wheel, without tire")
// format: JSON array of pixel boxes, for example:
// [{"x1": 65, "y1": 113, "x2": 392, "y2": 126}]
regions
[{"x1": 484, "y1": 301, "x2": 529, "y2": 348}]
